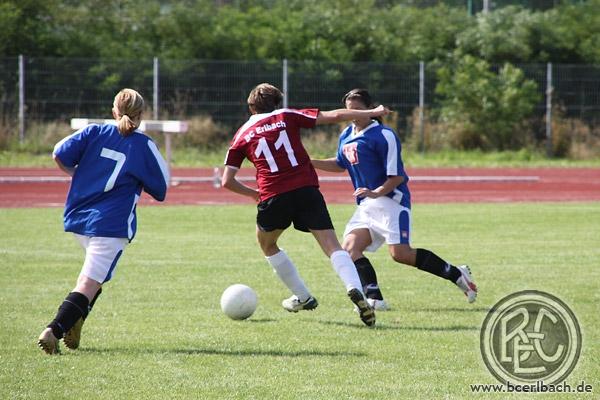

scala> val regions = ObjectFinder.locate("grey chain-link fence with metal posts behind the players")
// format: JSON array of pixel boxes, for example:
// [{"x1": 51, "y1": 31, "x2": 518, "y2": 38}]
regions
[{"x1": 0, "y1": 57, "x2": 600, "y2": 147}]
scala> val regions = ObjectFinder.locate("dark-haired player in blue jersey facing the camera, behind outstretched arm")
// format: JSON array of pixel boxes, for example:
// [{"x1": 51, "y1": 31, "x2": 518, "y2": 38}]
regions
[{"x1": 312, "y1": 89, "x2": 477, "y2": 310}]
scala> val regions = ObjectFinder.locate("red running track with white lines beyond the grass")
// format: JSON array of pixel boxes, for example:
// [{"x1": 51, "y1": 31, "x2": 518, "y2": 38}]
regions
[{"x1": 0, "y1": 168, "x2": 600, "y2": 208}]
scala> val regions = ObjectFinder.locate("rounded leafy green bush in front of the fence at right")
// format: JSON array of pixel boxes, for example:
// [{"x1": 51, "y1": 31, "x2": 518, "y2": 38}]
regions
[{"x1": 436, "y1": 55, "x2": 539, "y2": 150}]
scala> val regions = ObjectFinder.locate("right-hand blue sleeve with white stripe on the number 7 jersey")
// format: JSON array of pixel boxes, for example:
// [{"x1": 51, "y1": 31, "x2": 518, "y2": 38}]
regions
[{"x1": 139, "y1": 139, "x2": 170, "y2": 201}]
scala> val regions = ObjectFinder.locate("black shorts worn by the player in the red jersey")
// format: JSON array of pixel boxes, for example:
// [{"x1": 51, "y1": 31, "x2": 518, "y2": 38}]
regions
[{"x1": 256, "y1": 186, "x2": 333, "y2": 232}]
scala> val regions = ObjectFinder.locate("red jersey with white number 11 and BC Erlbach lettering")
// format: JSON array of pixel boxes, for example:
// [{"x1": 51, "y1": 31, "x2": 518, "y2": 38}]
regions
[{"x1": 225, "y1": 108, "x2": 319, "y2": 201}]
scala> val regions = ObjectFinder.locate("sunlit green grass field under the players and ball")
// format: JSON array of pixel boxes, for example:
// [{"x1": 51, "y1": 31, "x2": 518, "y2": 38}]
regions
[{"x1": 0, "y1": 203, "x2": 600, "y2": 400}]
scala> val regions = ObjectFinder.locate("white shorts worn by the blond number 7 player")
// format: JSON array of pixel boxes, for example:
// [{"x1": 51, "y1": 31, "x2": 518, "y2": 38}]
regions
[{"x1": 74, "y1": 233, "x2": 129, "y2": 283}]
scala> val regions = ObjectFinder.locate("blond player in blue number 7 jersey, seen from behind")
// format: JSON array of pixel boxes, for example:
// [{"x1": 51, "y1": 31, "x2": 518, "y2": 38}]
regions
[{"x1": 38, "y1": 89, "x2": 169, "y2": 354}]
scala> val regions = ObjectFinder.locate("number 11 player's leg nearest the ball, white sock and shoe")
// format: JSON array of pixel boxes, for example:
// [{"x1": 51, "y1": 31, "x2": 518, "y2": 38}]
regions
[{"x1": 256, "y1": 227, "x2": 319, "y2": 312}]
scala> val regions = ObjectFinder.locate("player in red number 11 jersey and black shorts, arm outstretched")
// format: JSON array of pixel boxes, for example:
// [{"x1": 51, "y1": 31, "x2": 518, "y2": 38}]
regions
[{"x1": 222, "y1": 83, "x2": 390, "y2": 326}]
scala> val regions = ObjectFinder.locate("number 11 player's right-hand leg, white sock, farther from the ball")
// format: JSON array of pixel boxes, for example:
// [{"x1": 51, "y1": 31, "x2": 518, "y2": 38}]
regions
[{"x1": 311, "y1": 229, "x2": 375, "y2": 326}]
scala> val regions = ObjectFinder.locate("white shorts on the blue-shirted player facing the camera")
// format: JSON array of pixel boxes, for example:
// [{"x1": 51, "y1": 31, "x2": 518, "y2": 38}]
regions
[{"x1": 344, "y1": 196, "x2": 411, "y2": 252}]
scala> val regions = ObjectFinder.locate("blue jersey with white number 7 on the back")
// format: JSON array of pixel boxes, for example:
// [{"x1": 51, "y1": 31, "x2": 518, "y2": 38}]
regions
[{"x1": 54, "y1": 124, "x2": 169, "y2": 241}]
